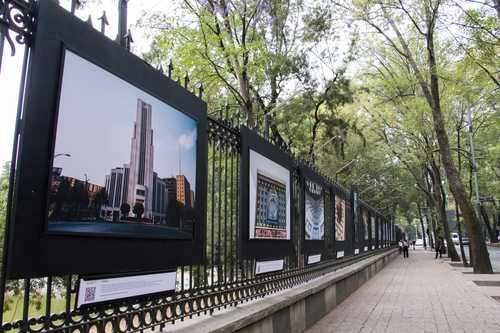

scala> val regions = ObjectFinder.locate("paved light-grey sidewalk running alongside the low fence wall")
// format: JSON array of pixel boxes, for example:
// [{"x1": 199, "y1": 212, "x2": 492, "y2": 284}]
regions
[{"x1": 306, "y1": 249, "x2": 500, "y2": 333}]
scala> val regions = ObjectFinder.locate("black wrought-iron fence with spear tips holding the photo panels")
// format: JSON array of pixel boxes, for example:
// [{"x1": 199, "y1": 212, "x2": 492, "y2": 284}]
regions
[{"x1": 0, "y1": 0, "x2": 395, "y2": 332}]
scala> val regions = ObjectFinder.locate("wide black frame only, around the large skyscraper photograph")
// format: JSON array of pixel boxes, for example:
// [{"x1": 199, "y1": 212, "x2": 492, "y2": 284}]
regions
[{"x1": 7, "y1": 1, "x2": 208, "y2": 278}]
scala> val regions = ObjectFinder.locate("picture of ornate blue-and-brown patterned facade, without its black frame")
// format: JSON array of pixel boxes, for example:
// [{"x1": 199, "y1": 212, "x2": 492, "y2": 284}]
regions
[{"x1": 249, "y1": 149, "x2": 291, "y2": 240}]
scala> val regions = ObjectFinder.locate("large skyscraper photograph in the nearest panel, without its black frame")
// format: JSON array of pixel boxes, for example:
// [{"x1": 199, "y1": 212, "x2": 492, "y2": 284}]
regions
[{"x1": 47, "y1": 50, "x2": 197, "y2": 239}]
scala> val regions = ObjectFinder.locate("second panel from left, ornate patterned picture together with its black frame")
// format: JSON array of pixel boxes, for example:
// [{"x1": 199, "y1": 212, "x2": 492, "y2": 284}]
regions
[{"x1": 240, "y1": 126, "x2": 294, "y2": 259}]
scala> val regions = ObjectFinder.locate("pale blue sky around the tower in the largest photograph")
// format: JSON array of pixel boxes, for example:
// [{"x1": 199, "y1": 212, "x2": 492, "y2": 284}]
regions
[{"x1": 54, "y1": 51, "x2": 196, "y2": 190}]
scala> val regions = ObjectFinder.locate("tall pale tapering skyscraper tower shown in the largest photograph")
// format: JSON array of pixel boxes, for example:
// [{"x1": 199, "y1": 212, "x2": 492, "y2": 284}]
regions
[{"x1": 127, "y1": 99, "x2": 154, "y2": 218}]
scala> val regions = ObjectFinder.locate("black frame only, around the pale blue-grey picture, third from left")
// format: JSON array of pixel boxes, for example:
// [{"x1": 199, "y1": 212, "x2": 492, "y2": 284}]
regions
[{"x1": 299, "y1": 165, "x2": 326, "y2": 258}]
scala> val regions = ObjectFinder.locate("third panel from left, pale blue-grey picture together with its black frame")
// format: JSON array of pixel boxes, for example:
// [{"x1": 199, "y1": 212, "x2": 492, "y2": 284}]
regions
[{"x1": 300, "y1": 166, "x2": 329, "y2": 255}]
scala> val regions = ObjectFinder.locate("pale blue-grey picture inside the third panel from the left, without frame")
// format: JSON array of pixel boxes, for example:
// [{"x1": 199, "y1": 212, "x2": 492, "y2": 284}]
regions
[{"x1": 304, "y1": 178, "x2": 325, "y2": 240}]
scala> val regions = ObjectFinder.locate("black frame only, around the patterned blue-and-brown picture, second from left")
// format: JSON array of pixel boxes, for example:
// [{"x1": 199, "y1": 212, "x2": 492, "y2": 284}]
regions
[{"x1": 239, "y1": 126, "x2": 296, "y2": 260}]
